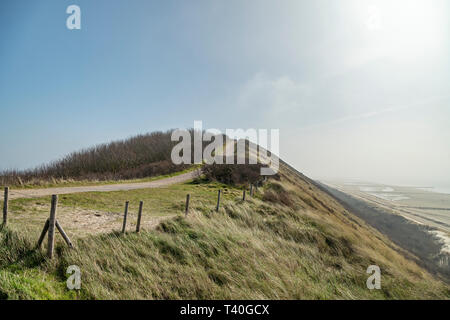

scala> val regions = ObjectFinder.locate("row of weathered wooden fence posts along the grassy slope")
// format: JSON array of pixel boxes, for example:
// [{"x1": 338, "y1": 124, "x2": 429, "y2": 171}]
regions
[{"x1": 2, "y1": 184, "x2": 258, "y2": 259}]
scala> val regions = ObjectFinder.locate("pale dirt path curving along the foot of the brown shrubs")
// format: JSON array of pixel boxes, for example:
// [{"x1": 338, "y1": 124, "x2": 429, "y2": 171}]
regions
[{"x1": 9, "y1": 171, "x2": 197, "y2": 200}]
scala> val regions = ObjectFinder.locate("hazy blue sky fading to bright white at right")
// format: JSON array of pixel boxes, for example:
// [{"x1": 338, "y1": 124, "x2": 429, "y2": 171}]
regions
[{"x1": 0, "y1": 0, "x2": 450, "y2": 186}]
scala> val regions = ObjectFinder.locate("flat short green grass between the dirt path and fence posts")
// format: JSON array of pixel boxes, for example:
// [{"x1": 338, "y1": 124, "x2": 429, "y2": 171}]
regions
[{"x1": 8, "y1": 182, "x2": 246, "y2": 237}]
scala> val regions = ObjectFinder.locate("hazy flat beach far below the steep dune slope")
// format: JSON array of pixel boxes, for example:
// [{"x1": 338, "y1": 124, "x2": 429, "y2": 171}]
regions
[{"x1": 320, "y1": 180, "x2": 450, "y2": 281}]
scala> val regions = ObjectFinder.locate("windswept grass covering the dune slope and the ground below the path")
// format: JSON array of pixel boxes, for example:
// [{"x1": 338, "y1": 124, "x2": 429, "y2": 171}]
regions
[{"x1": 0, "y1": 165, "x2": 450, "y2": 299}]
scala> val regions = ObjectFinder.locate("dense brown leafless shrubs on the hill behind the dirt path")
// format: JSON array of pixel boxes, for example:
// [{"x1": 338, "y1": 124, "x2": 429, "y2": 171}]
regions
[{"x1": 0, "y1": 131, "x2": 189, "y2": 185}]
